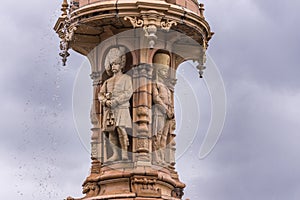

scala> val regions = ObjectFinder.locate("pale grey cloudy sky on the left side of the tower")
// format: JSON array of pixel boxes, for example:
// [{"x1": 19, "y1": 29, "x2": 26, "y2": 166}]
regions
[{"x1": 0, "y1": 1, "x2": 90, "y2": 199}]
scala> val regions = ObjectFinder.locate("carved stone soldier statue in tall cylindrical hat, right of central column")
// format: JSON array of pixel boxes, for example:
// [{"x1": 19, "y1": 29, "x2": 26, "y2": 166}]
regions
[{"x1": 152, "y1": 53, "x2": 175, "y2": 163}]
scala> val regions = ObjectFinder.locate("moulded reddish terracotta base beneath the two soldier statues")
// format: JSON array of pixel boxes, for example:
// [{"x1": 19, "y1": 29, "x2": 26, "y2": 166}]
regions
[{"x1": 67, "y1": 162, "x2": 185, "y2": 200}]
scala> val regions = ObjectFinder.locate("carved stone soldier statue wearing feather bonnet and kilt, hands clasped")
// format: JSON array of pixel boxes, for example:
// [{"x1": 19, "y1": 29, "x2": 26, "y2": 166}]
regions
[{"x1": 98, "y1": 47, "x2": 133, "y2": 161}]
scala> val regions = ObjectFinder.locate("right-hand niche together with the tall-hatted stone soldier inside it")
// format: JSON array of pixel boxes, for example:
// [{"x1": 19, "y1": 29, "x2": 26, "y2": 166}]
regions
[{"x1": 152, "y1": 51, "x2": 176, "y2": 167}]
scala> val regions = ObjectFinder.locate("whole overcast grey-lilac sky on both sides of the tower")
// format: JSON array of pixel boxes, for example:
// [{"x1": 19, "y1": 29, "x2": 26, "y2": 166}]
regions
[{"x1": 0, "y1": 0, "x2": 300, "y2": 200}]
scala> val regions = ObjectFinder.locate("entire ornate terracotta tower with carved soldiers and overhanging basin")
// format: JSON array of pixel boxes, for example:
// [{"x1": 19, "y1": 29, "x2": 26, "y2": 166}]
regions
[{"x1": 54, "y1": 0, "x2": 213, "y2": 200}]
